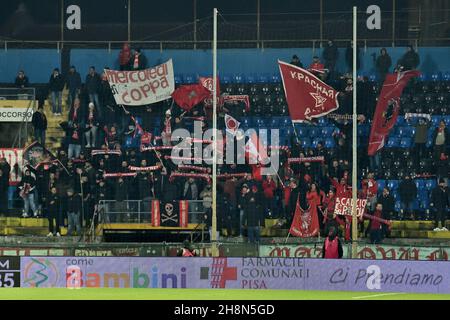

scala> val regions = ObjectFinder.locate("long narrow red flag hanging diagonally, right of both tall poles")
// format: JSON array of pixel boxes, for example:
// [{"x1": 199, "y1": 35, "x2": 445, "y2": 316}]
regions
[{"x1": 368, "y1": 70, "x2": 420, "y2": 156}]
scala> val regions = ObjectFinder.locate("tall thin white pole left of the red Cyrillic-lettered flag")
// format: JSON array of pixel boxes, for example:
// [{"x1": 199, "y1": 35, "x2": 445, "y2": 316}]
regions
[{"x1": 211, "y1": 8, "x2": 219, "y2": 257}]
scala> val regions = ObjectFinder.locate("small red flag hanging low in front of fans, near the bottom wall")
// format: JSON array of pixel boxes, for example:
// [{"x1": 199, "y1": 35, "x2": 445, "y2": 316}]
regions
[{"x1": 289, "y1": 200, "x2": 319, "y2": 238}]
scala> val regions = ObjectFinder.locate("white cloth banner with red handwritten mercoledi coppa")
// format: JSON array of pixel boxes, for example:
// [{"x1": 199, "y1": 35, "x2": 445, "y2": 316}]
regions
[{"x1": 104, "y1": 59, "x2": 175, "y2": 106}]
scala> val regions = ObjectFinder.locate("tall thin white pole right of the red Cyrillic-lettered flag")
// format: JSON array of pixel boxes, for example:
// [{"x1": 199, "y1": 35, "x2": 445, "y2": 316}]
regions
[{"x1": 352, "y1": 7, "x2": 358, "y2": 259}]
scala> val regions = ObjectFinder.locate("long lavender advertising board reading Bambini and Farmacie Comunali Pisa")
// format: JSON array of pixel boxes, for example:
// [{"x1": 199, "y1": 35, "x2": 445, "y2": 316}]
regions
[{"x1": 21, "y1": 257, "x2": 450, "y2": 293}]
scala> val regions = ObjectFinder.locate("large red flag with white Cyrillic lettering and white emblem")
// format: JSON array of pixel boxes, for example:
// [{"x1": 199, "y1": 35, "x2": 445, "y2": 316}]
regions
[{"x1": 278, "y1": 60, "x2": 339, "y2": 122}]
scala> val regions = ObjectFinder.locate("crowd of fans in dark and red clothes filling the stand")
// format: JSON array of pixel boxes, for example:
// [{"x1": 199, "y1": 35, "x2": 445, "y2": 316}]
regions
[{"x1": 0, "y1": 41, "x2": 450, "y2": 243}]
